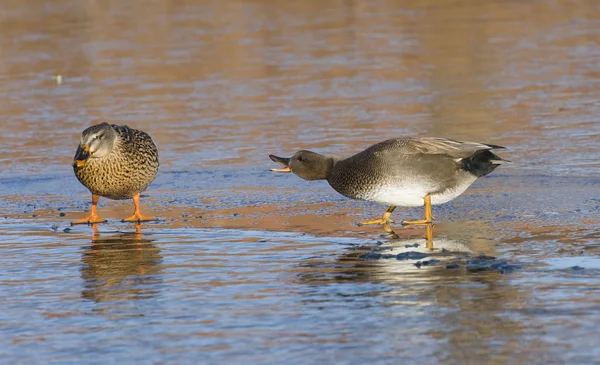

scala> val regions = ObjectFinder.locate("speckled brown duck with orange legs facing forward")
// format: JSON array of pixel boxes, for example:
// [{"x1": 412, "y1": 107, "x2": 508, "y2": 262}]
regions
[{"x1": 71, "y1": 123, "x2": 159, "y2": 224}]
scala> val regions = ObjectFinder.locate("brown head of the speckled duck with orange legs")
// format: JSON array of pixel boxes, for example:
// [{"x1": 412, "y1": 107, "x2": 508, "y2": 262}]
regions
[{"x1": 73, "y1": 123, "x2": 117, "y2": 167}]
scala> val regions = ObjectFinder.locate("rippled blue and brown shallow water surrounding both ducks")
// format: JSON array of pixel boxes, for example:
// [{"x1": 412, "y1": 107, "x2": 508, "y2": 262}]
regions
[{"x1": 0, "y1": 0, "x2": 600, "y2": 364}]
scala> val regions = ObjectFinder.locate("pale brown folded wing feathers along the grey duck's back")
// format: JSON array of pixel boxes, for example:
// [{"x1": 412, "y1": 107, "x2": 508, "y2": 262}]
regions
[{"x1": 404, "y1": 137, "x2": 505, "y2": 159}]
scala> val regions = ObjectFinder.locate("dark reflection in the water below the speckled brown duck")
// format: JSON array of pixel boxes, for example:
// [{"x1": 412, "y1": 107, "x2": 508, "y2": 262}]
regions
[{"x1": 81, "y1": 224, "x2": 162, "y2": 302}]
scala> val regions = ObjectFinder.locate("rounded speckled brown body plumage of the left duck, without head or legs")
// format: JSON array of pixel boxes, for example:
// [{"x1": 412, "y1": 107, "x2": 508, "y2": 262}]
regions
[{"x1": 73, "y1": 123, "x2": 159, "y2": 200}]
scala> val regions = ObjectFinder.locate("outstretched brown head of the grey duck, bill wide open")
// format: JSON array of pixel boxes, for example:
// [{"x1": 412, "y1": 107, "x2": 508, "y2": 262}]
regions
[{"x1": 269, "y1": 151, "x2": 333, "y2": 180}]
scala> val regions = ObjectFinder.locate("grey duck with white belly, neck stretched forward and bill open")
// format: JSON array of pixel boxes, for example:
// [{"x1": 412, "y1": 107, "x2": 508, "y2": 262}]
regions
[{"x1": 269, "y1": 137, "x2": 508, "y2": 224}]
